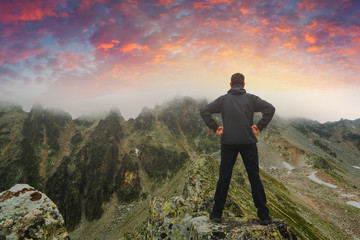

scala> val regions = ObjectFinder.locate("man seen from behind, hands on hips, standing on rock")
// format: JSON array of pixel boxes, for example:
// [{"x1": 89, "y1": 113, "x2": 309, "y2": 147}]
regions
[{"x1": 200, "y1": 73, "x2": 275, "y2": 225}]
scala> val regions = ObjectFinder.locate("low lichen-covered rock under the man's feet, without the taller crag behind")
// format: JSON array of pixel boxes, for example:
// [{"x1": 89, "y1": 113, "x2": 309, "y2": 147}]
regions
[{"x1": 143, "y1": 197, "x2": 297, "y2": 239}]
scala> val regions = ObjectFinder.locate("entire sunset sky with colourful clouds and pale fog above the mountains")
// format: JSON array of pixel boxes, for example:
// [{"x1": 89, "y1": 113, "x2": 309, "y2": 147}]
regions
[{"x1": 0, "y1": 0, "x2": 360, "y2": 122}]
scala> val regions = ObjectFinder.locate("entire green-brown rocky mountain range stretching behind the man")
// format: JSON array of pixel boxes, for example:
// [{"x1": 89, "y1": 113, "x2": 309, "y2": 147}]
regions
[{"x1": 0, "y1": 97, "x2": 360, "y2": 239}]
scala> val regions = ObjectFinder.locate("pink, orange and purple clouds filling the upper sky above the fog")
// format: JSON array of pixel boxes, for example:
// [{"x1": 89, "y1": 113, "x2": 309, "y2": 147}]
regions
[{"x1": 0, "y1": 0, "x2": 360, "y2": 104}]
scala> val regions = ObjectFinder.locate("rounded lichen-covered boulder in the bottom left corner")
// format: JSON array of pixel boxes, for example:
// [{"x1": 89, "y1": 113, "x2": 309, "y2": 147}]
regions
[{"x1": 0, "y1": 184, "x2": 70, "y2": 240}]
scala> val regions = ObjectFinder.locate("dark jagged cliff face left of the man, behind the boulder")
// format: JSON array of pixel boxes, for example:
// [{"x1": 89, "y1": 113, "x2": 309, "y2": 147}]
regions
[{"x1": 0, "y1": 100, "x2": 214, "y2": 230}]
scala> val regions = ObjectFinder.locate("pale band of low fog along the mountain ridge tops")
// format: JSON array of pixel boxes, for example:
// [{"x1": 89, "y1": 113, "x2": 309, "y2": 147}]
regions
[{"x1": 1, "y1": 85, "x2": 360, "y2": 123}]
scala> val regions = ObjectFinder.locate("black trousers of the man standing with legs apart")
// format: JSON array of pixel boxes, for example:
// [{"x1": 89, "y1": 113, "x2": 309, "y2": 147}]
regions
[{"x1": 212, "y1": 143, "x2": 269, "y2": 219}]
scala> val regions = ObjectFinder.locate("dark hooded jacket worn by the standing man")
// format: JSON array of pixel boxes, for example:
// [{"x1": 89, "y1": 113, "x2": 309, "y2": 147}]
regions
[{"x1": 200, "y1": 84, "x2": 275, "y2": 144}]
